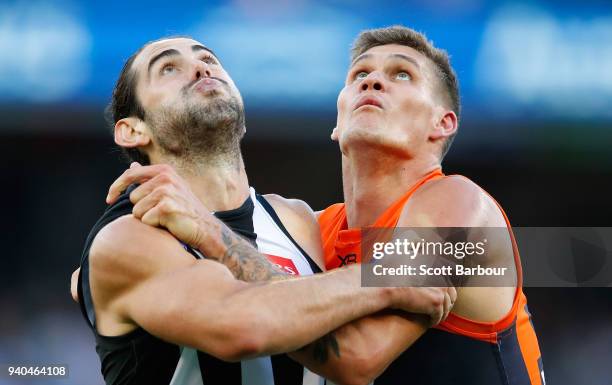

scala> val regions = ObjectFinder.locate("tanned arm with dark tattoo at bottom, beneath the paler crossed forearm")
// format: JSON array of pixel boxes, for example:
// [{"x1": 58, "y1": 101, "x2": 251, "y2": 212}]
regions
[{"x1": 289, "y1": 311, "x2": 428, "y2": 384}]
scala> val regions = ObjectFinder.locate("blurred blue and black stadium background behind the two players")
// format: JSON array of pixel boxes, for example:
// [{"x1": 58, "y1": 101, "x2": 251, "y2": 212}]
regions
[{"x1": 0, "y1": 0, "x2": 612, "y2": 385}]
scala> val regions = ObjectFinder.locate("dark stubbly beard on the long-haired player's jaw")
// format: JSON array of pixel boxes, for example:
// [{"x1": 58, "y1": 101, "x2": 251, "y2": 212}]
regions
[{"x1": 145, "y1": 93, "x2": 244, "y2": 163}]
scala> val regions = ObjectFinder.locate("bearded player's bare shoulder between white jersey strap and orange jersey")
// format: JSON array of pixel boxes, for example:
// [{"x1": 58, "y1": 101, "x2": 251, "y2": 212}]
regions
[{"x1": 264, "y1": 194, "x2": 323, "y2": 267}]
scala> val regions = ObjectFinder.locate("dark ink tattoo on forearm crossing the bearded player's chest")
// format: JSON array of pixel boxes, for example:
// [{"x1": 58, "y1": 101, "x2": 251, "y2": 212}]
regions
[{"x1": 219, "y1": 226, "x2": 287, "y2": 282}]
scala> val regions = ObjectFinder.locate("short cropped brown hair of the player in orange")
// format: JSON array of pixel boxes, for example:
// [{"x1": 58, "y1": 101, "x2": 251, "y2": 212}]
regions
[{"x1": 351, "y1": 25, "x2": 461, "y2": 158}]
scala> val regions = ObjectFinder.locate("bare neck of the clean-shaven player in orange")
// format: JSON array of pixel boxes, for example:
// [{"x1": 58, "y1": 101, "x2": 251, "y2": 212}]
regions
[{"x1": 342, "y1": 146, "x2": 440, "y2": 228}]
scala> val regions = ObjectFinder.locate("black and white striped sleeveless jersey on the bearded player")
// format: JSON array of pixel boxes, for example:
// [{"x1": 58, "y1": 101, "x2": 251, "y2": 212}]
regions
[{"x1": 78, "y1": 186, "x2": 324, "y2": 385}]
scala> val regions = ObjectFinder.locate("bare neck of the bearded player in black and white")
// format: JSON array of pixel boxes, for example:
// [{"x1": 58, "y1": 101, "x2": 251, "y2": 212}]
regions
[{"x1": 152, "y1": 154, "x2": 249, "y2": 211}]
